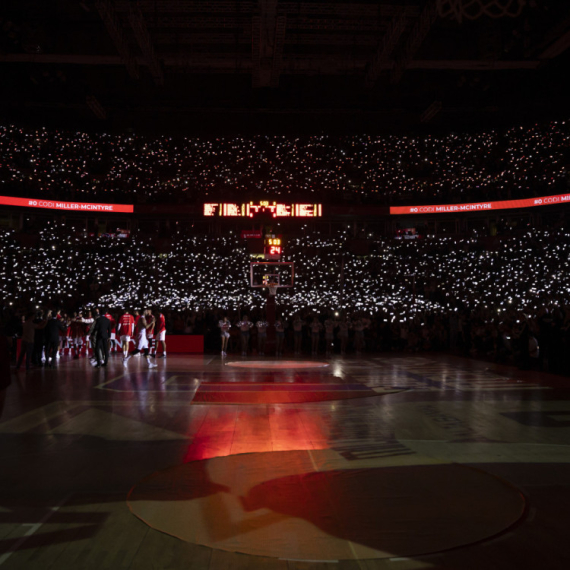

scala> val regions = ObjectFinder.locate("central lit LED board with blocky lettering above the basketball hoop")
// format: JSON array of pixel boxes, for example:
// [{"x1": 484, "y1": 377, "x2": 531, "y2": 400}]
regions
[{"x1": 204, "y1": 202, "x2": 323, "y2": 218}]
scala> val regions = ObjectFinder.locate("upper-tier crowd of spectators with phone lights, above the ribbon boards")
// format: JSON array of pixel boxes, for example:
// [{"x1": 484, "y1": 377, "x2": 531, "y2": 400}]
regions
[{"x1": 0, "y1": 121, "x2": 570, "y2": 205}]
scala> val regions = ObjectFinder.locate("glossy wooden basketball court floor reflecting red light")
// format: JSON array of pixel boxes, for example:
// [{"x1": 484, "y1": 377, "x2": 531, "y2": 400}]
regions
[{"x1": 0, "y1": 354, "x2": 570, "y2": 570}]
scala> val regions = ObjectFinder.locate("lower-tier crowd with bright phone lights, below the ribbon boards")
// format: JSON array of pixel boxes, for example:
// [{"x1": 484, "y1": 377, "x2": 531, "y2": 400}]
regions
[{"x1": 0, "y1": 222, "x2": 570, "y2": 373}]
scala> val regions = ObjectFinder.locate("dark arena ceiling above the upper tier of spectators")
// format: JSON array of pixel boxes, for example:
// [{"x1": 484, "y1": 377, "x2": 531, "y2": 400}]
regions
[{"x1": 0, "y1": 0, "x2": 570, "y2": 134}]
